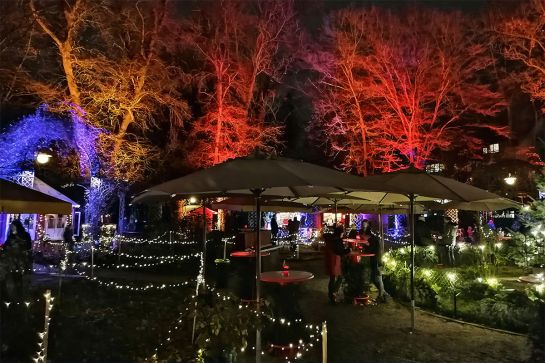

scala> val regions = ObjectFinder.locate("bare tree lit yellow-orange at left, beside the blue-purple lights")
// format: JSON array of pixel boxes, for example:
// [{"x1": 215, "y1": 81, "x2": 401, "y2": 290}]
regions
[{"x1": 29, "y1": 0, "x2": 189, "y2": 181}]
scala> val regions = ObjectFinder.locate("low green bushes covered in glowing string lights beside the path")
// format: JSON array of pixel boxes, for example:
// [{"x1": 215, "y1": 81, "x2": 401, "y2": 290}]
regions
[{"x1": 385, "y1": 248, "x2": 540, "y2": 332}]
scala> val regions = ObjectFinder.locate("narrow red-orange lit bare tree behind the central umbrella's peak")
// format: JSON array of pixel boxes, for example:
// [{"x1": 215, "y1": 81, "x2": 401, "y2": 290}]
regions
[{"x1": 186, "y1": 1, "x2": 295, "y2": 167}]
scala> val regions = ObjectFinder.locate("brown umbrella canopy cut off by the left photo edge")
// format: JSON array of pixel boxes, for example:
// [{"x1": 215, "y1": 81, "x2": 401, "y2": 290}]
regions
[{"x1": 0, "y1": 179, "x2": 72, "y2": 214}]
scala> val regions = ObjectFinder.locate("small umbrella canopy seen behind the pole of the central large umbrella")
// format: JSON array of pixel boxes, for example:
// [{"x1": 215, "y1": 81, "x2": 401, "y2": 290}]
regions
[{"x1": 211, "y1": 197, "x2": 312, "y2": 213}]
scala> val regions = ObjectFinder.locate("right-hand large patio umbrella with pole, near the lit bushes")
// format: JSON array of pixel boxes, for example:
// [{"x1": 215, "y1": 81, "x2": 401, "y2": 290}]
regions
[{"x1": 340, "y1": 168, "x2": 500, "y2": 331}]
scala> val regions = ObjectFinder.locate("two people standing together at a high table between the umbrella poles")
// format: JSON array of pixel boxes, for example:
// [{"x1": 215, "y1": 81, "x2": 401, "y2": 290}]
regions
[{"x1": 324, "y1": 219, "x2": 389, "y2": 305}]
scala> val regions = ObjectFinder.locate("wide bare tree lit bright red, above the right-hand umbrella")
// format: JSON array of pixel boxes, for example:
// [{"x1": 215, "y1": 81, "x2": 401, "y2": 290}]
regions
[{"x1": 303, "y1": 8, "x2": 505, "y2": 174}]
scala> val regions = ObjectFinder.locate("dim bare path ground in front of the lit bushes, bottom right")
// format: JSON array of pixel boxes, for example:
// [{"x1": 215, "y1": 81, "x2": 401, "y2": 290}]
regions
[{"x1": 292, "y1": 261, "x2": 530, "y2": 363}]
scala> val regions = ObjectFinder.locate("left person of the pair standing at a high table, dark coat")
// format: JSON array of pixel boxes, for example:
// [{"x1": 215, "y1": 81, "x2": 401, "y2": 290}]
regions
[{"x1": 324, "y1": 226, "x2": 350, "y2": 304}]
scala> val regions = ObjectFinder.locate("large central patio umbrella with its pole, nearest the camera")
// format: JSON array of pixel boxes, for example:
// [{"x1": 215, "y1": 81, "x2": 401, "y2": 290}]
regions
[{"x1": 147, "y1": 153, "x2": 388, "y2": 362}]
